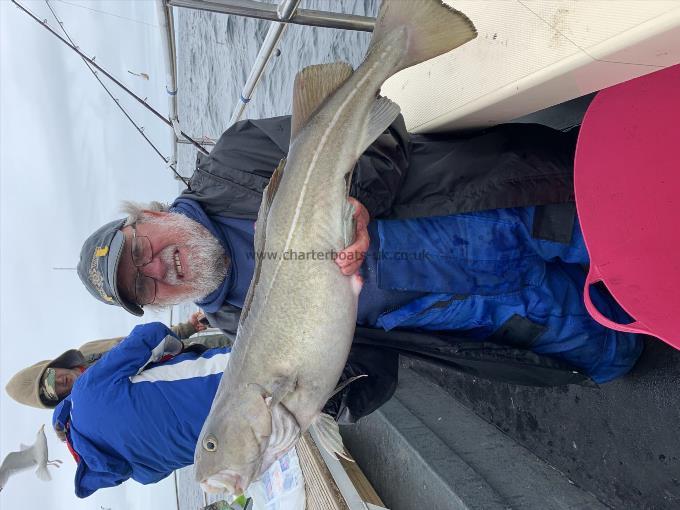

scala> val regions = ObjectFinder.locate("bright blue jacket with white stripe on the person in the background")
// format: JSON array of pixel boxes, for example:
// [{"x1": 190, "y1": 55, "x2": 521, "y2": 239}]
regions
[{"x1": 53, "y1": 323, "x2": 229, "y2": 498}]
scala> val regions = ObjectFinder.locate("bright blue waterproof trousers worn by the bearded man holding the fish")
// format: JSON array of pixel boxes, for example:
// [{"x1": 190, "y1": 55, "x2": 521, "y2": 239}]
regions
[{"x1": 375, "y1": 207, "x2": 643, "y2": 382}]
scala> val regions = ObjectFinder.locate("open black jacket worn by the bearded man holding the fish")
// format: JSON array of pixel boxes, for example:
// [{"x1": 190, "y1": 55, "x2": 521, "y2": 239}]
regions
[{"x1": 182, "y1": 116, "x2": 584, "y2": 421}]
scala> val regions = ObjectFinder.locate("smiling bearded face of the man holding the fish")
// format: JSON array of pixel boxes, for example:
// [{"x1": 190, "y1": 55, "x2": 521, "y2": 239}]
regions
[{"x1": 118, "y1": 212, "x2": 227, "y2": 306}]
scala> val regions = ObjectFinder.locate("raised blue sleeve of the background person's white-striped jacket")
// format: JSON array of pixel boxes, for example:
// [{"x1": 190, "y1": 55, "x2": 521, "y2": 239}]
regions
[{"x1": 85, "y1": 322, "x2": 181, "y2": 380}]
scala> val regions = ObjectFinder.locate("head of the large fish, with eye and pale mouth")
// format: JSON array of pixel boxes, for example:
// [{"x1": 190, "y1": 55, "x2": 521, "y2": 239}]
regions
[{"x1": 194, "y1": 387, "x2": 272, "y2": 494}]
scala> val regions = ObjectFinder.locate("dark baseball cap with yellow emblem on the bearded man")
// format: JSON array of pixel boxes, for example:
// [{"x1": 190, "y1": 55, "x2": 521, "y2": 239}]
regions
[{"x1": 78, "y1": 219, "x2": 144, "y2": 316}]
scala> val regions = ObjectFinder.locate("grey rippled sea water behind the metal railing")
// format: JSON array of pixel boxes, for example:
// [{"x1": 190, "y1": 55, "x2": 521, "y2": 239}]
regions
[{"x1": 175, "y1": 0, "x2": 379, "y2": 175}]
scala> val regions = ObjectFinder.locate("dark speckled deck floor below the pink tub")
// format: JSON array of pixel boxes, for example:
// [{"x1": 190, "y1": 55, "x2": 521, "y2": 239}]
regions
[{"x1": 407, "y1": 338, "x2": 680, "y2": 510}]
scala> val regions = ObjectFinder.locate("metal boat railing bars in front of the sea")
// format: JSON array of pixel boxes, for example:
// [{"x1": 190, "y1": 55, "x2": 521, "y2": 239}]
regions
[{"x1": 157, "y1": 0, "x2": 375, "y2": 179}]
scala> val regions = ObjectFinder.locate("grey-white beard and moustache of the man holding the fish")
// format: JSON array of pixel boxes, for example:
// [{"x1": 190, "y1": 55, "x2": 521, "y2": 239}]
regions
[{"x1": 144, "y1": 213, "x2": 230, "y2": 308}]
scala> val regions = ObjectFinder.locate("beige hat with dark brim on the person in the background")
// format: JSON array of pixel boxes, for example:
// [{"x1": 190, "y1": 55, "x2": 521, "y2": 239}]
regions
[{"x1": 5, "y1": 349, "x2": 85, "y2": 409}]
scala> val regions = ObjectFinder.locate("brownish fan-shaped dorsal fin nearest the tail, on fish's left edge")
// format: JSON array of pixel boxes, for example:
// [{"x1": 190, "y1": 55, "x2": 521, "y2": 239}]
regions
[{"x1": 290, "y1": 62, "x2": 352, "y2": 140}]
